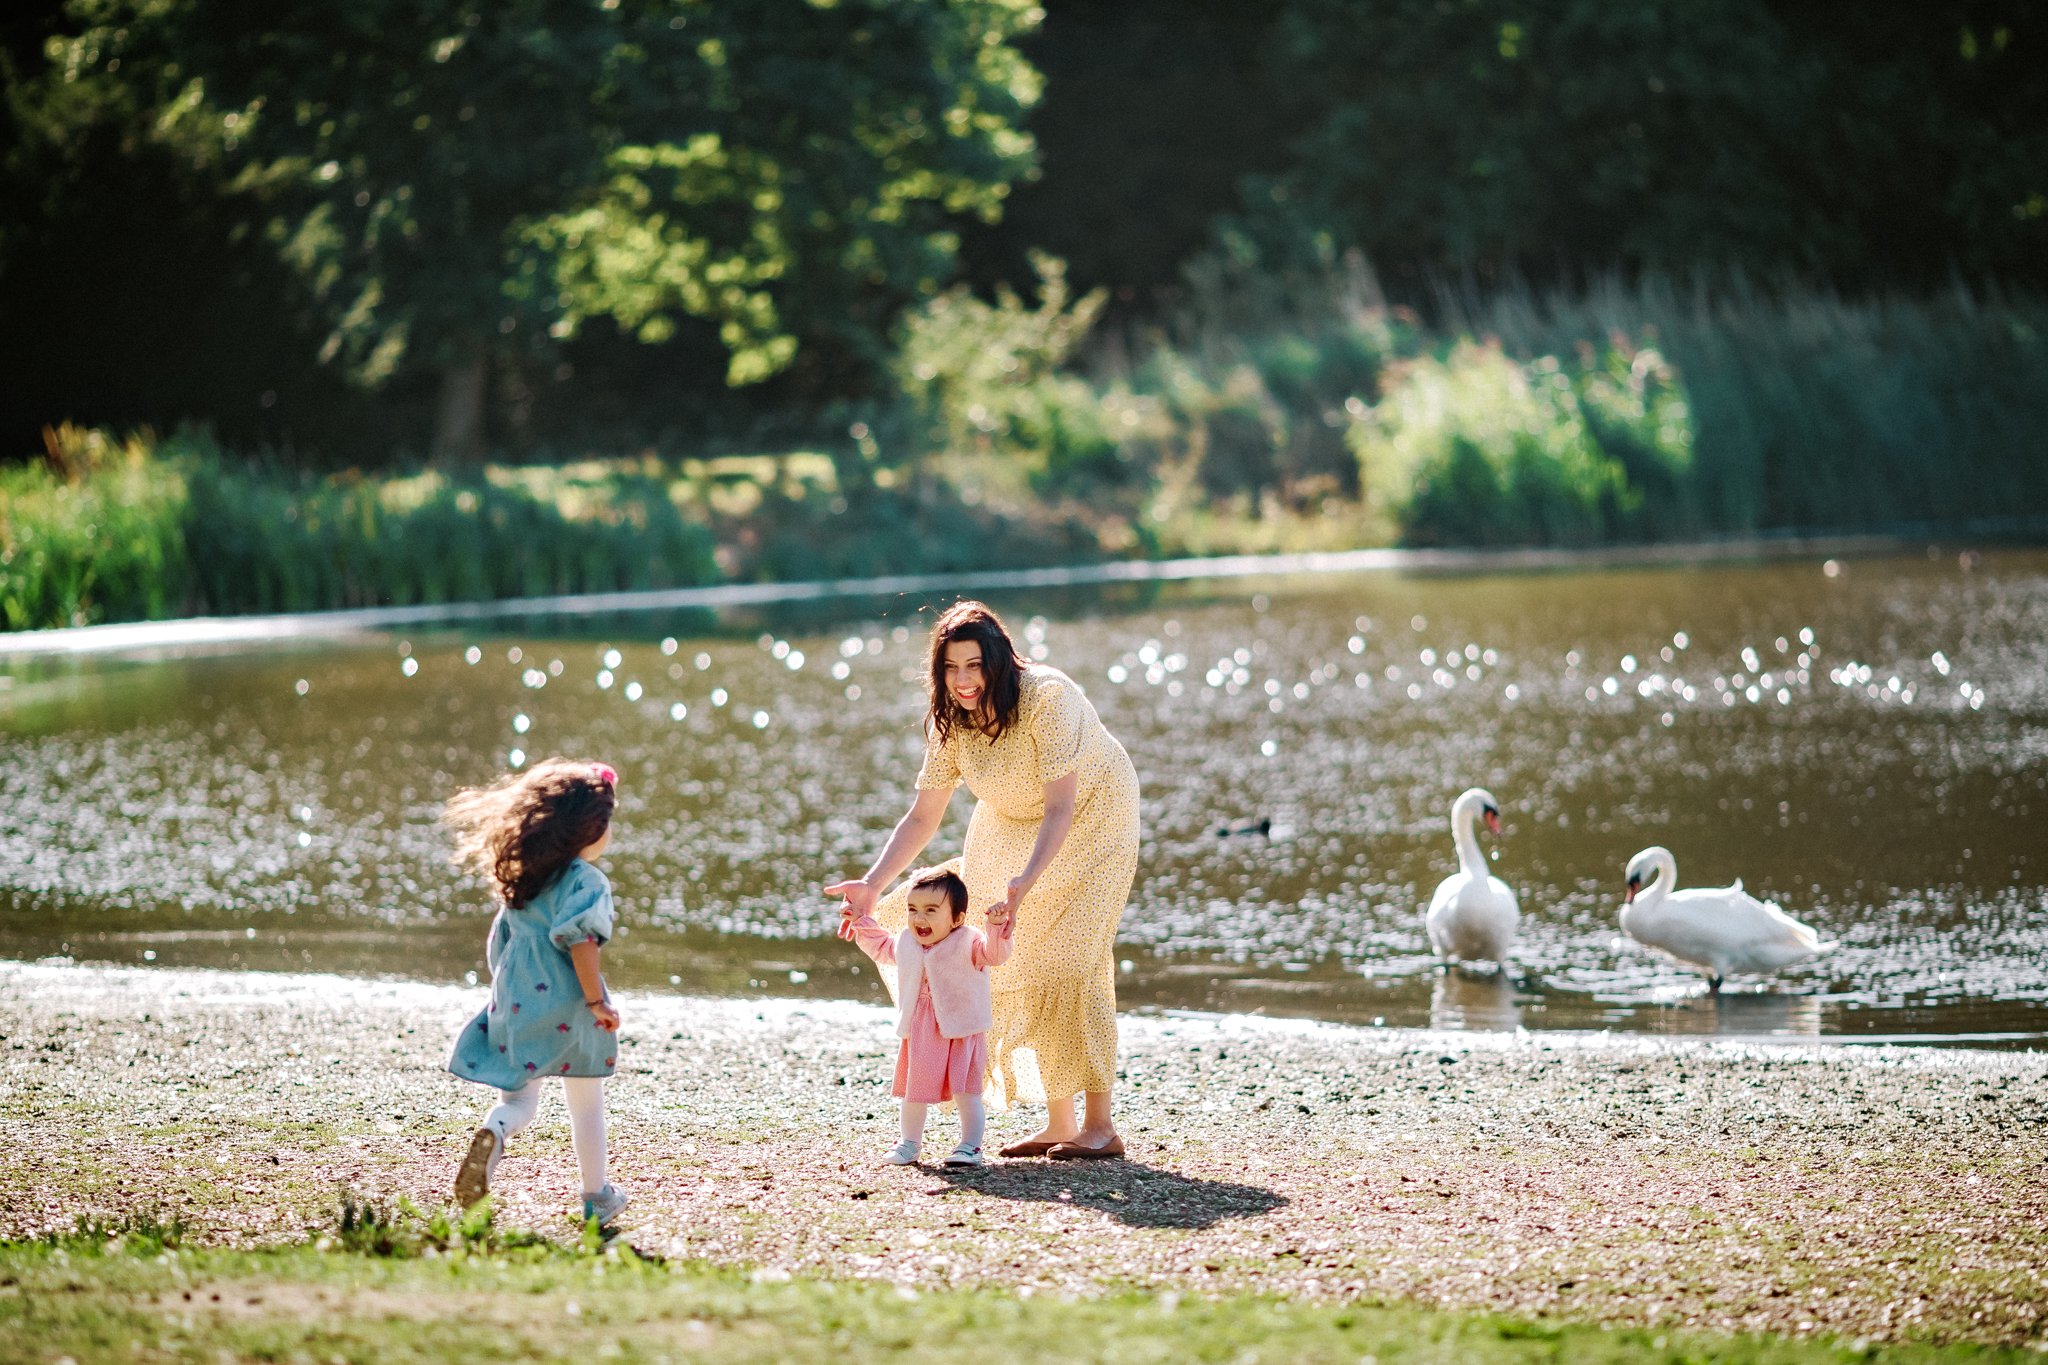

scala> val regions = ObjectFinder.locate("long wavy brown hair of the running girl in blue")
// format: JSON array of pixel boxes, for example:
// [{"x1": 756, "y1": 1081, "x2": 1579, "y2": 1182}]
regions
[{"x1": 440, "y1": 759, "x2": 618, "y2": 909}]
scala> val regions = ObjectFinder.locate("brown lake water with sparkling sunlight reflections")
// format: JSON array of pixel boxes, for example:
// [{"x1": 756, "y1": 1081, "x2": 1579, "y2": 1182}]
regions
[{"x1": 0, "y1": 551, "x2": 2048, "y2": 1046}]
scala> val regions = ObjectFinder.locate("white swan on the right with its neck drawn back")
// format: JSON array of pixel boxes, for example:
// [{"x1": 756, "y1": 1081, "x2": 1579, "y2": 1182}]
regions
[{"x1": 1622, "y1": 847, "x2": 1835, "y2": 990}]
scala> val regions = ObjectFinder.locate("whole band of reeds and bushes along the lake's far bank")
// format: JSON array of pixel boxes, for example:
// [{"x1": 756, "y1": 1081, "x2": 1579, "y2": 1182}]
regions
[{"x1": 0, "y1": 272, "x2": 2048, "y2": 630}]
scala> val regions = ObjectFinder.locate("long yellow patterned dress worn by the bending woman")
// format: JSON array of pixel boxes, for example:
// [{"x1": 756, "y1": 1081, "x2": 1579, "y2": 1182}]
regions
[{"x1": 874, "y1": 663, "x2": 1139, "y2": 1109}]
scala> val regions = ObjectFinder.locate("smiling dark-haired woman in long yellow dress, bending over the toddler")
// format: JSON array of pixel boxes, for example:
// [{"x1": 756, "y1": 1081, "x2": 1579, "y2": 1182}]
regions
[{"x1": 825, "y1": 602, "x2": 1139, "y2": 1160}]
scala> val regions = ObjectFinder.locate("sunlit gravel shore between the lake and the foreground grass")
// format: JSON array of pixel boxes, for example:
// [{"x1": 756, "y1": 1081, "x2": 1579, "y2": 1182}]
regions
[{"x1": 0, "y1": 962, "x2": 2048, "y2": 1349}]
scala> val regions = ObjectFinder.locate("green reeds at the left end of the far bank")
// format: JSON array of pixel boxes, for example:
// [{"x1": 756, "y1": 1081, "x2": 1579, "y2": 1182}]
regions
[{"x1": 0, "y1": 428, "x2": 719, "y2": 630}]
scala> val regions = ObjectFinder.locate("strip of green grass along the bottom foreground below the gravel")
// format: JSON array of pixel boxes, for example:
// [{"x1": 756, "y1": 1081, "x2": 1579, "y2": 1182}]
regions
[{"x1": 0, "y1": 1207, "x2": 2023, "y2": 1365}]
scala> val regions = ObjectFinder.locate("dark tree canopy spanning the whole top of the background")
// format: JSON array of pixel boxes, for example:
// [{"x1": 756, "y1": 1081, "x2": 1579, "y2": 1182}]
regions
[{"x1": 0, "y1": 0, "x2": 2048, "y2": 458}]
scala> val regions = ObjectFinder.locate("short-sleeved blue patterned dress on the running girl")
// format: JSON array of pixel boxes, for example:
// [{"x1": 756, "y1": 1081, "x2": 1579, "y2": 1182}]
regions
[{"x1": 449, "y1": 860, "x2": 618, "y2": 1091}]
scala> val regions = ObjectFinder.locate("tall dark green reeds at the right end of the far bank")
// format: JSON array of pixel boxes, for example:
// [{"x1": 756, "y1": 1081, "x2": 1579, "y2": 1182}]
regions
[{"x1": 1440, "y1": 278, "x2": 2048, "y2": 532}]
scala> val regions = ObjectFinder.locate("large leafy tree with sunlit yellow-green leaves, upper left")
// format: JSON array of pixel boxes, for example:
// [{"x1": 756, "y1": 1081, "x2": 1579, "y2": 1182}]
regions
[{"x1": 47, "y1": 0, "x2": 1038, "y2": 454}]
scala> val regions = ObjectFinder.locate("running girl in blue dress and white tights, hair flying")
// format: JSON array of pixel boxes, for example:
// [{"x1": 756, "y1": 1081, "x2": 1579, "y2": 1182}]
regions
[{"x1": 442, "y1": 759, "x2": 627, "y2": 1226}]
